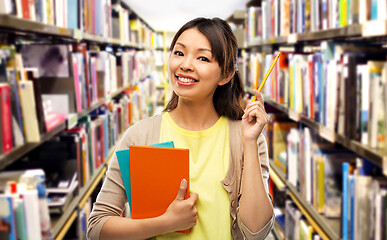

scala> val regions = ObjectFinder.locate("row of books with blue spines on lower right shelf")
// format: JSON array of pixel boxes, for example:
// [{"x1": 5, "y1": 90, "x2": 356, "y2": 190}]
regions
[{"x1": 266, "y1": 117, "x2": 387, "y2": 239}]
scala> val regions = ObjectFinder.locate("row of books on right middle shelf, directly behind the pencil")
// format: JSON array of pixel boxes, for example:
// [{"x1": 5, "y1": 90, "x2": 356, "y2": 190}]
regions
[{"x1": 244, "y1": 42, "x2": 387, "y2": 149}]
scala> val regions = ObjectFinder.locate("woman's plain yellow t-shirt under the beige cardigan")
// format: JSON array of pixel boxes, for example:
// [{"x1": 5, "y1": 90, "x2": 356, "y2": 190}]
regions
[{"x1": 156, "y1": 113, "x2": 233, "y2": 240}]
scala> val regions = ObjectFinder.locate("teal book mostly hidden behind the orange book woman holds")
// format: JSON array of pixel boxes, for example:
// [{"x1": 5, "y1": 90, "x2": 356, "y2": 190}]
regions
[{"x1": 116, "y1": 141, "x2": 175, "y2": 206}]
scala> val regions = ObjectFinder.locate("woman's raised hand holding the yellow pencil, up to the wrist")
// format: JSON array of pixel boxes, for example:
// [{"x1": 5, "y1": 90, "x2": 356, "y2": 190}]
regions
[{"x1": 242, "y1": 89, "x2": 270, "y2": 142}]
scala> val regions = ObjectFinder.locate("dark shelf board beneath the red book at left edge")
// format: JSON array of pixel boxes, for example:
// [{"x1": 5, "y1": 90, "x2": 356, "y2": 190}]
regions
[{"x1": 0, "y1": 122, "x2": 66, "y2": 170}]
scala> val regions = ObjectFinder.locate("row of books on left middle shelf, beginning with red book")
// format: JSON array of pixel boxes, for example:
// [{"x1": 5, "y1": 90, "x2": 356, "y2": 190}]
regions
[{"x1": 0, "y1": 43, "x2": 158, "y2": 153}]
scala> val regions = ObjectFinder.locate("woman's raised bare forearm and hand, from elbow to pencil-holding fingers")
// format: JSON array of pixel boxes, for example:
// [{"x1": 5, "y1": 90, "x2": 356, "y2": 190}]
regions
[{"x1": 239, "y1": 89, "x2": 273, "y2": 233}]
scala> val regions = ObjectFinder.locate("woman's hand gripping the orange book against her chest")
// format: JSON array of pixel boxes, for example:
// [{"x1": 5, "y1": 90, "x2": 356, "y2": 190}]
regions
[{"x1": 163, "y1": 179, "x2": 198, "y2": 232}]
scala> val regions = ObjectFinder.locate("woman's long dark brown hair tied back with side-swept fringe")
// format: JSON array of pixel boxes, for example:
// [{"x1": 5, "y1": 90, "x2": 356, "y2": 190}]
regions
[{"x1": 164, "y1": 18, "x2": 244, "y2": 120}]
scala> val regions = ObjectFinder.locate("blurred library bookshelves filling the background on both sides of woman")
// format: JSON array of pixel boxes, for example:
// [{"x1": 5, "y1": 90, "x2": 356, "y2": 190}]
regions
[{"x1": 0, "y1": 0, "x2": 387, "y2": 240}]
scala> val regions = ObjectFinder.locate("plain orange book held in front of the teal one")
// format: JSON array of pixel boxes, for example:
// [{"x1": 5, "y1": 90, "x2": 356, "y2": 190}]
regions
[{"x1": 129, "y1": 145, "x2": 189, "y2": 233}]
